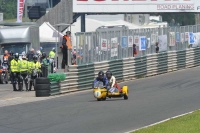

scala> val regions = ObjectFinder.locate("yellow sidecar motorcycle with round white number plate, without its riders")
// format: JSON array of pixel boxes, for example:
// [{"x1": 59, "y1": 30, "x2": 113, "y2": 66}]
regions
[{"x1": 93, "y1": 81, "x2": 128, "y2": 101}]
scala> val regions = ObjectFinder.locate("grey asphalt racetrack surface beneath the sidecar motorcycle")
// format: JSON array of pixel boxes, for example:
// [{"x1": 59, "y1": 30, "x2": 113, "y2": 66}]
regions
[{"x1": 0, "y1": 68, "x2": 200, "y2": 133}]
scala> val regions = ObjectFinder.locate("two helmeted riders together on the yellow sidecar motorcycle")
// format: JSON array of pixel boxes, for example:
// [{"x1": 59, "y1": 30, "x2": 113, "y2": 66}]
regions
[{"x1": 94, "y1": 71, "x2": 122, "y2": 93}]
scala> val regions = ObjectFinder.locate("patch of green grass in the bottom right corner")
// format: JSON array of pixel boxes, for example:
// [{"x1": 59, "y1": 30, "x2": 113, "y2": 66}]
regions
[{"x1": 132, "y1": 111, "x2": 200, "y2": 133}]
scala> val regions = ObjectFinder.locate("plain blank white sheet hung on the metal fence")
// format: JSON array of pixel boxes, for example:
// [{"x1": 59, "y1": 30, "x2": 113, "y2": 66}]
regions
[{"x1": 158, "y1": 35, "x2": 167, "y2": 51}]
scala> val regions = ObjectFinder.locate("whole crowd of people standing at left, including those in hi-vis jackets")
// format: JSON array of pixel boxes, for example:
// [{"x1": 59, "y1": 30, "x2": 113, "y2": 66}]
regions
[{"x1": 0, "y1": 47, "x2": 56, "y2": 91}]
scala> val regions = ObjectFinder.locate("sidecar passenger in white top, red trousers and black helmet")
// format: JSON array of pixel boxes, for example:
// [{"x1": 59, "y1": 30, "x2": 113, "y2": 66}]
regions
[{"x1": 106, "y1": 71, "x2": 122, "y2": 92}]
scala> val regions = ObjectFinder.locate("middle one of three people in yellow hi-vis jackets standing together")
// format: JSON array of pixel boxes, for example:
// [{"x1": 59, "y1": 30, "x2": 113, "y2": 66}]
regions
[{"x1": 19, "y1": 55, "x2": 29, "y2": 91}]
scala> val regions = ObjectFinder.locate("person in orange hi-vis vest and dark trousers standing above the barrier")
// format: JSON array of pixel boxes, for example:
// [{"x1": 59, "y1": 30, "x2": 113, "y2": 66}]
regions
[{"x1": 61, "y1": 31, "x2": 72, "y2": 72}]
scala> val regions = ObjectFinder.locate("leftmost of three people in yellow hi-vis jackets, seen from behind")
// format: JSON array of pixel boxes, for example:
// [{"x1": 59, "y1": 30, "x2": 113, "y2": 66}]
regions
[{"x1": 10, "y1": 53, "x2": 20, "y2": 91}]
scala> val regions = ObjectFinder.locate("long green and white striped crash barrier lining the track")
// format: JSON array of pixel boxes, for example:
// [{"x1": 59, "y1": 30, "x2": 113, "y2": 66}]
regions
[{"x1": 52, "y1": 48, "x2": 200, "y2": 93}]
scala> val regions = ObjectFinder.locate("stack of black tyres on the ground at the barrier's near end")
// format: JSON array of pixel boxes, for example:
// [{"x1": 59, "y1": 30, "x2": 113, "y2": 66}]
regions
[{"x1": 35, "y1": 77, "x2": 50, "y2": 97}]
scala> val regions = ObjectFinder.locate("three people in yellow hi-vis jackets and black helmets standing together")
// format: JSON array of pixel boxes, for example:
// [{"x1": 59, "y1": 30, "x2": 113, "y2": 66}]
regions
[{"x1": 10, "y1": 53, "x2": 41, "y2": 91}]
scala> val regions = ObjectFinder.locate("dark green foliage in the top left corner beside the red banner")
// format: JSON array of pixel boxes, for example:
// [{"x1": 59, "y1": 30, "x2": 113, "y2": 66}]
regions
[{"x1": 0, "y1": 0, "x2": 17, "y2": 19}]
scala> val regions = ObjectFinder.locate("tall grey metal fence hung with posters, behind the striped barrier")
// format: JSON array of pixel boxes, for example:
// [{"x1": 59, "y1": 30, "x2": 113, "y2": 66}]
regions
[{"x1": 74, "y1": 25, "x2": 200, "y2": 65}]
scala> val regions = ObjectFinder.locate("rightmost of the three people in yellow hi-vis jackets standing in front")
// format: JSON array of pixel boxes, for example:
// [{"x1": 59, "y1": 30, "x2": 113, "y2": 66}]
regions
[{"x1": 29, "y1": 55, "x2": 41, "y2": 91}]
